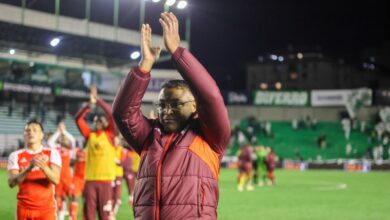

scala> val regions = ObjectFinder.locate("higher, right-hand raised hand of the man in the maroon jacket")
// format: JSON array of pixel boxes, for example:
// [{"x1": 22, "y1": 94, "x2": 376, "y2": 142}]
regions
[{"x1": 159, "y1": 12, "x2": 180, "y2": 54}]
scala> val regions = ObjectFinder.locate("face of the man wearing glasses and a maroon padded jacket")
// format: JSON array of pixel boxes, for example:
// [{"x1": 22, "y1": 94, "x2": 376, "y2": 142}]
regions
[{"x1": 157, "y1": 87, "x2": 196, "y2": 133}]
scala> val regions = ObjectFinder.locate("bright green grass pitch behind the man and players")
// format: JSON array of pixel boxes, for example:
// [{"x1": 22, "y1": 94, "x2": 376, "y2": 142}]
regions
[{"x1": 0, "y1": 169, "x2": 390, "y2": 220}]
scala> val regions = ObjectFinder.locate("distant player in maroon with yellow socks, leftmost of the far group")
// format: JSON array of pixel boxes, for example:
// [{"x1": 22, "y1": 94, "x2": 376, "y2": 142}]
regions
[{"x1": 237, "y1": 144, "x2": 253, "y2": 192}]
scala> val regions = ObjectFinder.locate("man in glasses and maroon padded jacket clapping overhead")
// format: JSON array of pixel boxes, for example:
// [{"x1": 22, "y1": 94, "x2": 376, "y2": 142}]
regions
[{"x1": 113, "y1": 13, "x2": 230, "y2": 220}]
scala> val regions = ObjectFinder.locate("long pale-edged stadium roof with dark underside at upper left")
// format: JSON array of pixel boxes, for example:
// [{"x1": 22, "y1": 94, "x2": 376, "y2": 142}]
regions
[{"x1": 0, "y1": 0, "x2": 187, "y2": 72}]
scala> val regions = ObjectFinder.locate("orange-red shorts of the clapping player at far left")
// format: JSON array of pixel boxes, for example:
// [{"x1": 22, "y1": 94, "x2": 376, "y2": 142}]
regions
[{"x1": 16, "y1": 205, "x2": 57, "y2": 220}]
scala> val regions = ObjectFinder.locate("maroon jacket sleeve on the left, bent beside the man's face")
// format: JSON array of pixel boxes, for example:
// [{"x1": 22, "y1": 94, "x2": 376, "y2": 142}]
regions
[{"x1": 113, "y1": 68, "x2": 152, "y2": 154}]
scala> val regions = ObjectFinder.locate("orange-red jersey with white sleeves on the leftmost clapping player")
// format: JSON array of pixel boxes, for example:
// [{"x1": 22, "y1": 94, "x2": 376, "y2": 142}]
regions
[{"x1": 7, "y1": 146, "x2": 61, "y2": 210}]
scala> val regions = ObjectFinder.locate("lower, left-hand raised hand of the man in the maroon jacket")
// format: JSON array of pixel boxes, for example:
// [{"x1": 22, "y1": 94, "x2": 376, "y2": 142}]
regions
[{"x1": 139, "y1": 24, "x2": 161, "y2": 72}]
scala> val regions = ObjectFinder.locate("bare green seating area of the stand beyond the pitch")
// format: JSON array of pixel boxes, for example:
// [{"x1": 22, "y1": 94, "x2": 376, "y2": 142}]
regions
[{"x1": 228, "y1": 120, "x2": 370, "y2": 160}]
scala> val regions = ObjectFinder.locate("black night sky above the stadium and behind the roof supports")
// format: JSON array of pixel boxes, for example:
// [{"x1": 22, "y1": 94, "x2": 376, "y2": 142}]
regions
[{"x1": 0, "y1": 0, "x2": 390, "y2": 89}]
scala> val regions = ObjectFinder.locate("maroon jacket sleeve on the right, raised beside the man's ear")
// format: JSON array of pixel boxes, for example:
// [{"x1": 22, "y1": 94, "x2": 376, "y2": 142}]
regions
[{"x1": 172, "y1": 47, "x2": 230, "y2": 155}]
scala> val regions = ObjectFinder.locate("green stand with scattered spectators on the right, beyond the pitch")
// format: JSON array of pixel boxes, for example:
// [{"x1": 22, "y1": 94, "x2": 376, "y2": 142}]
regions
[{"x1": 229, "y1": 113, "x2": 390, "y2": 161}]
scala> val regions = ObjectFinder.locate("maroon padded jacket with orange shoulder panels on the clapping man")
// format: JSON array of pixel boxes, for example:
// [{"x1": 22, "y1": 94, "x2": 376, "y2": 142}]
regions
[{"x1": 113, "y1": 48, "x2": 230, "y2": 220}]
